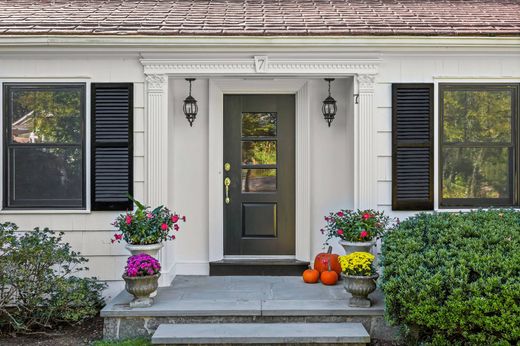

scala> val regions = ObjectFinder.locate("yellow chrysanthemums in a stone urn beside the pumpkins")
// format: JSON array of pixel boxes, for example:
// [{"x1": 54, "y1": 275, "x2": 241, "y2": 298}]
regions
[{"x1": 339, "y1": 252, "x2": 379, "y2": 308}]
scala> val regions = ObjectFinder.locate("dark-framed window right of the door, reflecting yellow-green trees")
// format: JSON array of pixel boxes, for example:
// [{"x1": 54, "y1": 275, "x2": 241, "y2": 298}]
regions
[{"x1": 439, "y1": 84, "x2": 520, "y2": 207}]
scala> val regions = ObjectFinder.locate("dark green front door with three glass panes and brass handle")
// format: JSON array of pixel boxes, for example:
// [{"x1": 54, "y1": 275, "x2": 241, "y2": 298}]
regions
[{"x1": 223, "y1": 95, "x2": 295, "y2": 256}]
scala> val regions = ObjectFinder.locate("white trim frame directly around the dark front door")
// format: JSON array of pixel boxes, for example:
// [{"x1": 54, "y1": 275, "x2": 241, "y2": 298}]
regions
[{"x1": 208, "y1": 79, "x2": 311, "y2": 262}]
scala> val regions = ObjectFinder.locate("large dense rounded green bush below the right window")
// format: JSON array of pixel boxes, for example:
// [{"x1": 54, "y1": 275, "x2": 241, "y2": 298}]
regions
[{"x1": 381, "y1": 210, "x2": 520, "y2": 345}]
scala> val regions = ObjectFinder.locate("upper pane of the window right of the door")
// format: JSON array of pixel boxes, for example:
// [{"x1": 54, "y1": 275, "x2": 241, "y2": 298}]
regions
[{"x1": 443, "y1": 90, "x2": 512, "y2": 143}]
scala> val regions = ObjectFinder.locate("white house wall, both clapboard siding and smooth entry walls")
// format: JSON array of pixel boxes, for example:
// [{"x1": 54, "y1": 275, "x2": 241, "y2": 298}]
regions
[{"x1": 0, "y1": 45, "x2": 520, "y2": 294}]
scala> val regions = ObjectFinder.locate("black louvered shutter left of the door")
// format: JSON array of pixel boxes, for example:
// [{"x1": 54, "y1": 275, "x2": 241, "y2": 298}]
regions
[{"x1": 91, "y1": 83, "x2": 134, "y2": 210}]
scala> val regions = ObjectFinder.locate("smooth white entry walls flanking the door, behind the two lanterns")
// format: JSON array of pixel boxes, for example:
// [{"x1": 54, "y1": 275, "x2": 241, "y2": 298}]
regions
[{"x1": 169, "y1": 78, "x2": 353, "y2": 274}]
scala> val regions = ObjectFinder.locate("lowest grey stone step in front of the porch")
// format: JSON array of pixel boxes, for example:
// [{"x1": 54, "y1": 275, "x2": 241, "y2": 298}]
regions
[{"x1": 152, "y1": 323, "x2": 370, "y2": 345}]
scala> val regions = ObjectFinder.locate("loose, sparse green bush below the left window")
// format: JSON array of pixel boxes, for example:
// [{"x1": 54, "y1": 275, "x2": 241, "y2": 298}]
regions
[{"x1": 0, "y1": 223, "x2": 105, "y2": 332}]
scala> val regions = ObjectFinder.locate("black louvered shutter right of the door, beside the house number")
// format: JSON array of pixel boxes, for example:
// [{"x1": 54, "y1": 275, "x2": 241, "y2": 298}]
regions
[{"x1": 392, "y1": 84, "x2": 434, "y2": 210}]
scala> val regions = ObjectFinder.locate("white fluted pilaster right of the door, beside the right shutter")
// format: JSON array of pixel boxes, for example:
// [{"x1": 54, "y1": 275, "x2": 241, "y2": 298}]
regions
[{"x1": 355, "y1": 74, "x2": 377, "y2": 209}]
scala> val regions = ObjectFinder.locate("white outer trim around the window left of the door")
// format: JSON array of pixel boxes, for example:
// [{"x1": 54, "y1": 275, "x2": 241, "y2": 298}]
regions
[{"x1": 0, "y1": 77, "x2": 91, "y2": 215}]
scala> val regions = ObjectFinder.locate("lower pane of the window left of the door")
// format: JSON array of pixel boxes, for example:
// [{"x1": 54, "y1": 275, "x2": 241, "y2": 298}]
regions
[{"x1": 9, "y1": 147, "x2": 83, "y2": 207}]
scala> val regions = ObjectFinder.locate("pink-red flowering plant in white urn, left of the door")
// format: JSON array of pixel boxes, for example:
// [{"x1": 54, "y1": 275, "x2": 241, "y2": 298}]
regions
[{"x1": 112, "y1": 199, "x2": 186, "y2": 258}]
